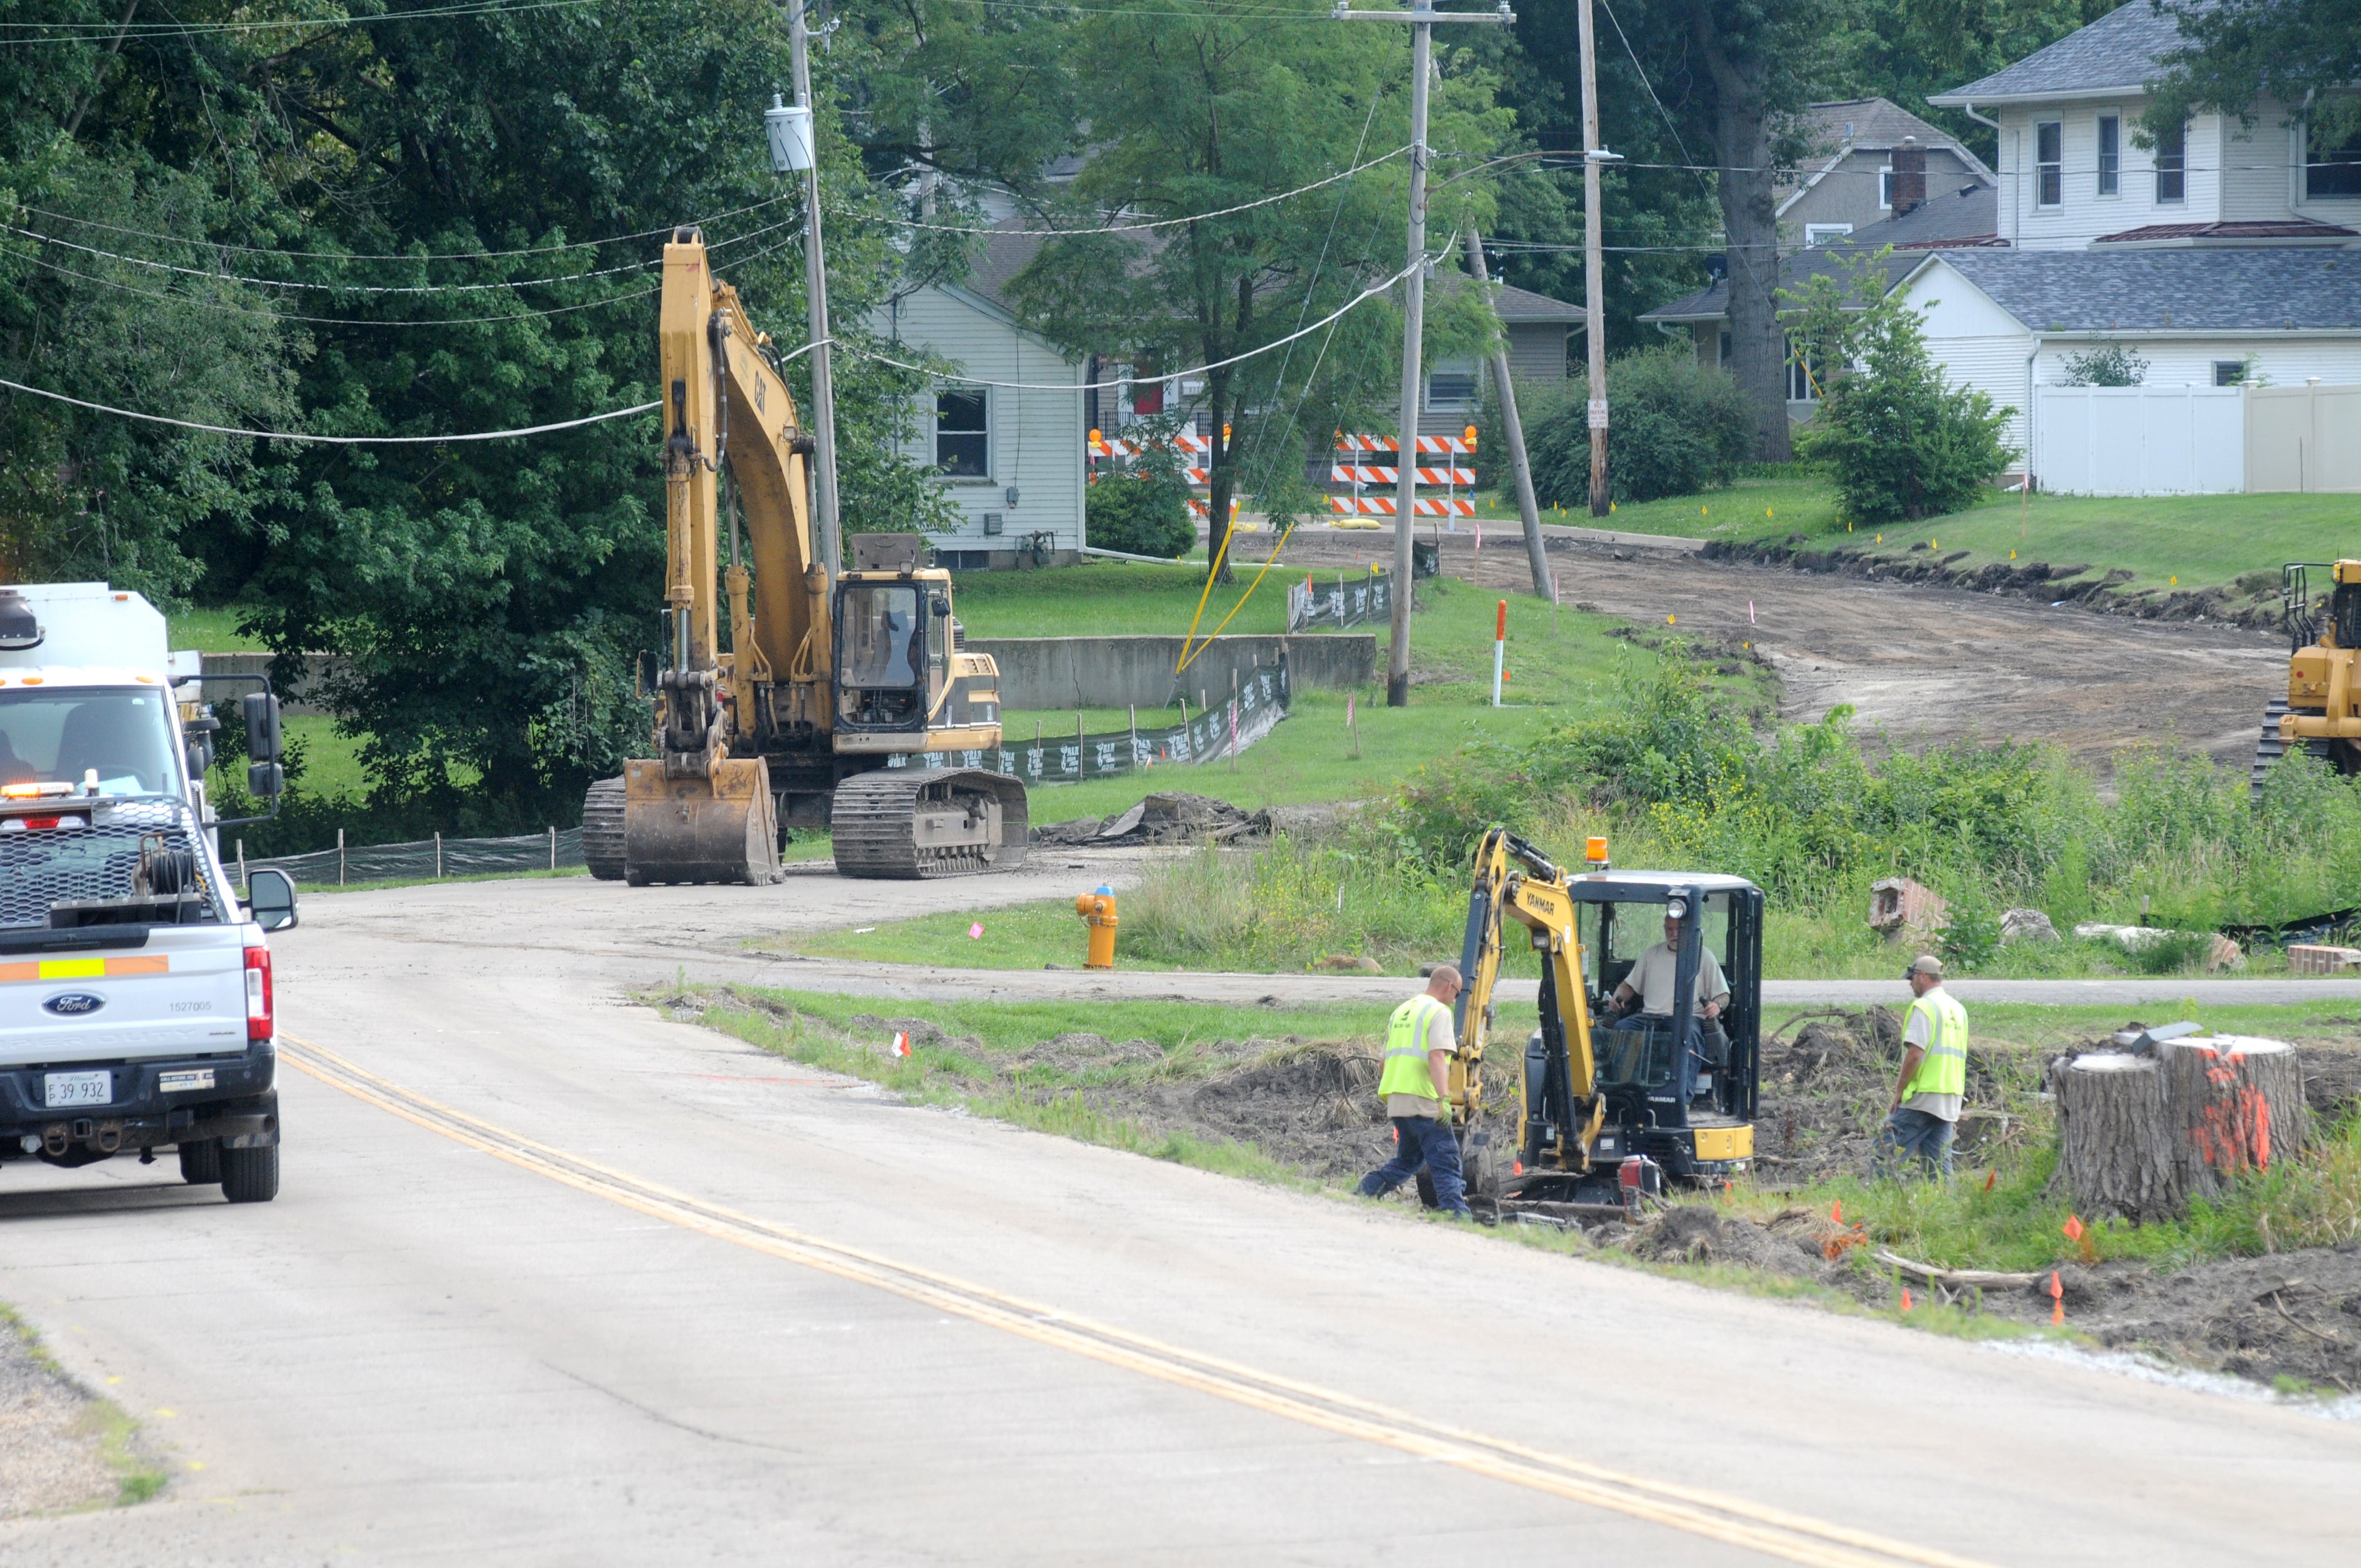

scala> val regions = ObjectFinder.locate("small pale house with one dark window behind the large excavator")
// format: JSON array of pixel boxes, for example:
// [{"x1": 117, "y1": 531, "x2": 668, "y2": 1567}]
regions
[{"x1": 868, "y1": 236, "x2": 1091, "y2": 571}]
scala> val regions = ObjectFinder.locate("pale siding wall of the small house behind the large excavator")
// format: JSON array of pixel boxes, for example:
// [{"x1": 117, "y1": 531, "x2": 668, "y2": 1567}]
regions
[{"x1": 873, "y1": 288, "x2": 1086, "y2": 550}]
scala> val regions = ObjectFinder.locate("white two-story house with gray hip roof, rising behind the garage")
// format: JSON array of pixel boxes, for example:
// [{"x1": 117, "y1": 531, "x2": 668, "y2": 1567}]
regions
[{"x1": 1927, "y1": 0, "x2": 2361, "y2": 251}]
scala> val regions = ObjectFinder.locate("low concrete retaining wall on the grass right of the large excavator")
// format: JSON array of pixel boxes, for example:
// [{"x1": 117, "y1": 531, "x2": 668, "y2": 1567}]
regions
[{"x1": 964, "y1": 633, "x2": 1377, "y2": 711}]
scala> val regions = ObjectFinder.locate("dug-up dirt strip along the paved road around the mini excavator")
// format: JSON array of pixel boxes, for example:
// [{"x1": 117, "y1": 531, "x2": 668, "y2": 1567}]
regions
[{"x1": 712, "y1": 987, "x2": 2361, "y2": 1393}]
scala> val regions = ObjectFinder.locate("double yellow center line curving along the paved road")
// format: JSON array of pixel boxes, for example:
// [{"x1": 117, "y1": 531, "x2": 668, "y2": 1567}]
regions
[{"x1": 279, "y1": 1035, "x2": 1985, "y2": 1568}]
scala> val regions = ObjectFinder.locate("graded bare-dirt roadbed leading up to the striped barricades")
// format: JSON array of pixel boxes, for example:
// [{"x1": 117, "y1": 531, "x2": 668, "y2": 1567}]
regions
[{"x1": 1275, "y1": 524, "x2": 2286, "y2": 775}]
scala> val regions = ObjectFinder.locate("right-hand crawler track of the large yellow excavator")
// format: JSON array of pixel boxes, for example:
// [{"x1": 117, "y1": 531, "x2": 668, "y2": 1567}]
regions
[{"x1": 829, "y1": 767, "x2": 1030, "y2": 881}]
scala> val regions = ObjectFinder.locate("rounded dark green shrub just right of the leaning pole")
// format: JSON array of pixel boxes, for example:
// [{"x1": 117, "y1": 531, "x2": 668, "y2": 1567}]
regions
[{"x1": 1511, "y1": 345, "x2": 1754, "y2": 505}]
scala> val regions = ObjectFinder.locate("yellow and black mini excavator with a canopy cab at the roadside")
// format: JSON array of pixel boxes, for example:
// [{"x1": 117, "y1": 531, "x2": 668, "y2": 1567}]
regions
[{"x1": 1450, "y1": 826, "x2": 1764, "y2": 1216}]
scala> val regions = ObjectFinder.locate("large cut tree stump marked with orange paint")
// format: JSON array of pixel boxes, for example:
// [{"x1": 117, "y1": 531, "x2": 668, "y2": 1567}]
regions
[{"x1": 2049, "y1": 1035, "x2": 2309, "y2": 1221}]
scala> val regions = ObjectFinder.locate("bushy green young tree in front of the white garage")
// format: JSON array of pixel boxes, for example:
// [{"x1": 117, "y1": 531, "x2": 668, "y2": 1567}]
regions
[{"x1": 1787, "y1": 251, "x2": 2011, "y2": 522}]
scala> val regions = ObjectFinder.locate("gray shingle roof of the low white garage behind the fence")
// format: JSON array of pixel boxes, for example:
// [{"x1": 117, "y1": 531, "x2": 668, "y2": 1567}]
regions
[{"x1": 1938, "y1": 248, "x2": 2361, "y2": 333}]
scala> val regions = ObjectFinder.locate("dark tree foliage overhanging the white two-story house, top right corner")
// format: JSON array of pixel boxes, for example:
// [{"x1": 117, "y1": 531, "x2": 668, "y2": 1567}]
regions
[{"x1": 2141, "y1": 0, "x2": 2361, "y2": 139}]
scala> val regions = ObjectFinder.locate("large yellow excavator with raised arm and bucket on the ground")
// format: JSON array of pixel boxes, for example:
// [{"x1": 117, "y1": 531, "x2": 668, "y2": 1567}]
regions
[{"x1": 583, "y1": 229, "x2": 1027, "y2": 885}]
